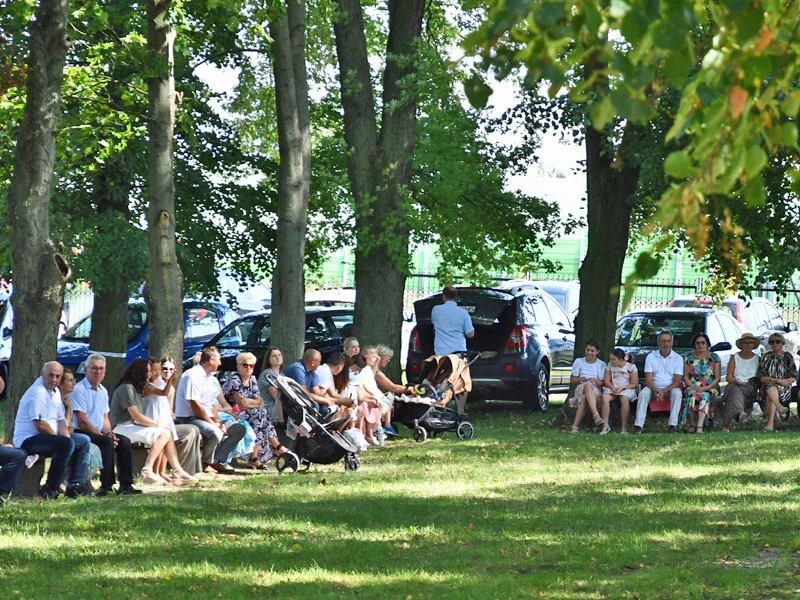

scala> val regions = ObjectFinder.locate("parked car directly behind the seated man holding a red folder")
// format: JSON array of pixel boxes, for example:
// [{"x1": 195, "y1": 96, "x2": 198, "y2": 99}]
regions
[{"x1": 615, "y1": 308, "x2": 742, "y2": 385}]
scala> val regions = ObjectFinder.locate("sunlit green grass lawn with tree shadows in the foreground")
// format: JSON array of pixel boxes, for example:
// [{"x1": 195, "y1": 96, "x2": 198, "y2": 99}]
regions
[{"x1": 0, "y1": 403, "x2": 800, "y2": 600}]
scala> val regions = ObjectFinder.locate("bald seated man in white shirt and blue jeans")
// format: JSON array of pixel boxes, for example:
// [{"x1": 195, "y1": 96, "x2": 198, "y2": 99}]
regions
[{"x1": 14, "y1": 361, "x2": 94, "y2": 499}]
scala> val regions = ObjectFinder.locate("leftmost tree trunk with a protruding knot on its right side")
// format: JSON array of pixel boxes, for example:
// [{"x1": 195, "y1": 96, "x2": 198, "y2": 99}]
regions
[{"x1": 6, "y1": 0, "x2": 71, "y2": 439}]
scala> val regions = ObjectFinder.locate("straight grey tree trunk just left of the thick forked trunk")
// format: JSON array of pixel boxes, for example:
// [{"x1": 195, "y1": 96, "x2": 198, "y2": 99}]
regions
[{"x1": 270, "y1": 0, "x2": 311, "y2": 362}]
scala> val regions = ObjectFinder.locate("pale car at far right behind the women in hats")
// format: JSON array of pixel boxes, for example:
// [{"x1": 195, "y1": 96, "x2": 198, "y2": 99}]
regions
[{"x1": 669, "y1": 294, "x2": 798, "y2": 355}]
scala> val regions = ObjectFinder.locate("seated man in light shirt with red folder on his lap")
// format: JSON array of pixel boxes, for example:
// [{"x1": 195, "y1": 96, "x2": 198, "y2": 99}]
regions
[{"x1": 633, "y1": 329, "x2": 683, "y2": 433}]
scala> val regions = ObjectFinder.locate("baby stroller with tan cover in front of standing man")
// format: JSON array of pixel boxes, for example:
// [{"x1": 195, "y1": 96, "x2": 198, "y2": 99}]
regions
[{"x1": 392, "y1": 352, "x2": 480, "y2": 442}]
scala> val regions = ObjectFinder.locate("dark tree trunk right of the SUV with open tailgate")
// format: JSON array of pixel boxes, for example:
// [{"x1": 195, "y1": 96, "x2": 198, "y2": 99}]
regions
[{"x1": 575, "y1": 119, "x2": 639, "y2": 361}]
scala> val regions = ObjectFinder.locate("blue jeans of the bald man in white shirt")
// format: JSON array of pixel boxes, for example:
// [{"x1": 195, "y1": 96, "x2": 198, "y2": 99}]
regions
[{"x1": 22, "y1": 433, "x2": 92, "y2": 491}]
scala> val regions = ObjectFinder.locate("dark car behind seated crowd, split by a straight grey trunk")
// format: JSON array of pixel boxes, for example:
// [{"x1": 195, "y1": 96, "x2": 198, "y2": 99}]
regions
[{"x1": 189, "y1": 306, "x2": 353, "y2": 381}]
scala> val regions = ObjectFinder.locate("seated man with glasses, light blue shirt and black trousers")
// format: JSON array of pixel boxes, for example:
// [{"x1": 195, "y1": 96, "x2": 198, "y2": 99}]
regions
[{"x1": 70, "y1": 354, "x2": 142, "y2": 496}]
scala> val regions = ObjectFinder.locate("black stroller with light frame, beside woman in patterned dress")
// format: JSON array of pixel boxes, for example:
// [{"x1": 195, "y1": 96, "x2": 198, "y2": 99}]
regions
[{"x1": 267, "y1": 373, "x2": 361, "y2": 473}]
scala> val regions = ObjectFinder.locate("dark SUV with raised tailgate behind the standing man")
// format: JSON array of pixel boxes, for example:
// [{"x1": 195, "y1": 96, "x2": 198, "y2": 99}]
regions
[{"x1": 406, "y1": 281, "x2": 575, "y2": 410}]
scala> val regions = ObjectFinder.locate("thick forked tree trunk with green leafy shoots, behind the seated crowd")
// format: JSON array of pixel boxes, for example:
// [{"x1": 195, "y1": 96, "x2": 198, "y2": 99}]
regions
[{"x1": 334, "y1": 0, "x2": 426, "y2": 379}]
